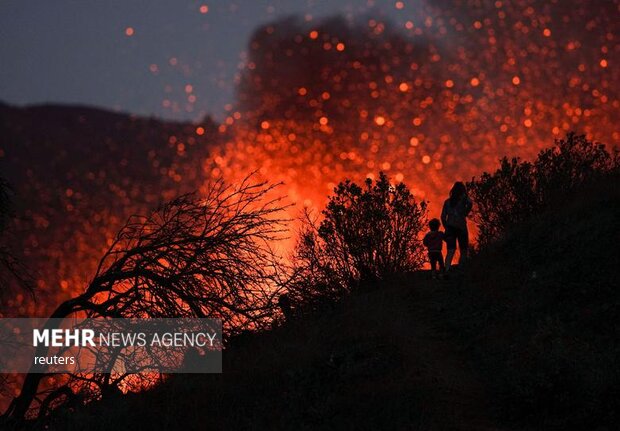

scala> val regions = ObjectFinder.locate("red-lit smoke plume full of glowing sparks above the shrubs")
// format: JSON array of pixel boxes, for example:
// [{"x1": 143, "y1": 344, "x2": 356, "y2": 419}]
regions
[{"x1": 212, "y1": 0, "x2": 620, "y2": 210}]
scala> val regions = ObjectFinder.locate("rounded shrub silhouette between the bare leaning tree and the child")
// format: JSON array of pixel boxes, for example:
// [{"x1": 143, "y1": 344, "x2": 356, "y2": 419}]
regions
[{"x1": 293, "y1": 173, "x2": 426, "y2": 308}]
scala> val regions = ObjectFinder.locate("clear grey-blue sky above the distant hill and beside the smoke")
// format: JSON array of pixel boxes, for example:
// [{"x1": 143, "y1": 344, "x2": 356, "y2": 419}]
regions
[{"x1": 0, "y1": 0, "x2": 419, "y2": 120}]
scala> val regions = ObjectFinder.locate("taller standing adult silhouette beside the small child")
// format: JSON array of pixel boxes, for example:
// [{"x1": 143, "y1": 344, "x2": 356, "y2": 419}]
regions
[{"x1": 441, "y1": 181, "x2": 472, "y2": 271}]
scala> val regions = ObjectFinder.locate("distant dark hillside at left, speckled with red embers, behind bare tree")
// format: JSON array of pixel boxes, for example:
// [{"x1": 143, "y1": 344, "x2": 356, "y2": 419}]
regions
[{"x1": 0, "y1": 105, "x2": 217, "y2": 315}]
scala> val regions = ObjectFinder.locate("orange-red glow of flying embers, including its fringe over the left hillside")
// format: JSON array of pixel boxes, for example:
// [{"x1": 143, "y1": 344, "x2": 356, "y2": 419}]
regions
[{"x1": 19, "y1": 0, "x2": 620, "y2": 324}]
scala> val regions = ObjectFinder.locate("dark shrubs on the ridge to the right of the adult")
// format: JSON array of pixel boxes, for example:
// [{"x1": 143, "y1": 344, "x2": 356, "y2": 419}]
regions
[{"x1": 468, "y1": 132, "x2": 619, "y2": 247}]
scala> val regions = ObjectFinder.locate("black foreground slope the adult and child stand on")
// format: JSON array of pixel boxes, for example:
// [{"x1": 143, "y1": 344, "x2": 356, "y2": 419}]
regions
[{"x1": 34, "y1": 176, "x2": 620, "y2": 430}]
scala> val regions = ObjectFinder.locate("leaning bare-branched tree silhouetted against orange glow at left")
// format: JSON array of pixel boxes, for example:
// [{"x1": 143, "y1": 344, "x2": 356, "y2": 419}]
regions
[{"x1": 5, "y1": 177, "x2": 284, "y2": 420}]
